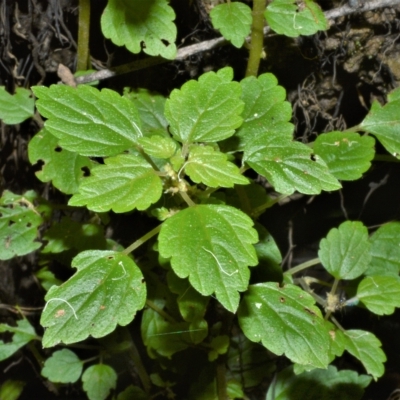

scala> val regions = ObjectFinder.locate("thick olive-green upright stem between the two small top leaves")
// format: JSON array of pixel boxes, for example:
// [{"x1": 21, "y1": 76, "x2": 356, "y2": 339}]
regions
[{"x1": 246, "y1": 0, "x2": 266, "y2": 76}]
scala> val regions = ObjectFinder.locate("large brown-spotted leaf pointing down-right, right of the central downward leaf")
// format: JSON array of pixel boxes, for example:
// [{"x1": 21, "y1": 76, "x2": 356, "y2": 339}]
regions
[{"x1": 238, "y1": 282, "x2": 330, "y2": 368}]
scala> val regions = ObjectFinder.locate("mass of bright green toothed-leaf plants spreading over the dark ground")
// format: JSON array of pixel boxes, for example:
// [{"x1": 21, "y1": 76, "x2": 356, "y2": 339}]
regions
[{"x1": 0, "y1": 0, "x2": 400, "y2": 400}]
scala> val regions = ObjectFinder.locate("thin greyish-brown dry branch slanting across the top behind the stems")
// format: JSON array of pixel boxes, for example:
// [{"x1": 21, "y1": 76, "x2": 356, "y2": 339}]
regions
[{"x1": 76, "y1": 0, "x2": 400, "y2": 84}]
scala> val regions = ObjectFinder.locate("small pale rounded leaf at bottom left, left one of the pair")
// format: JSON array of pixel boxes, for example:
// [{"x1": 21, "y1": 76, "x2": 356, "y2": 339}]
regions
[{"x1": 42, "y1": 349, "x2": 83, "y2": 383}]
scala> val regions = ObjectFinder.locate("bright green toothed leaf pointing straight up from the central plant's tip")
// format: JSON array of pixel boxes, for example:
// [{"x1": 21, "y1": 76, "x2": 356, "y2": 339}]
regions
[{"x1": 165, "y1": 67, "x2": 244, "y2": 144}]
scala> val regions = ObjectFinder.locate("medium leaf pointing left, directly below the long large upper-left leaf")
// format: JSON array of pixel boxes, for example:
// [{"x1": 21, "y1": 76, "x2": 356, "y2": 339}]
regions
[{"x1": 68, "y1": 154, "x2": 162, "y2": 213}]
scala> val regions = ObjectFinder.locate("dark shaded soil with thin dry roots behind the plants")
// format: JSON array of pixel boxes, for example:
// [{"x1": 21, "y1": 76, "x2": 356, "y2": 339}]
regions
[{"x1": 0, "y1": 0, "x2": 400, "y2": 400}]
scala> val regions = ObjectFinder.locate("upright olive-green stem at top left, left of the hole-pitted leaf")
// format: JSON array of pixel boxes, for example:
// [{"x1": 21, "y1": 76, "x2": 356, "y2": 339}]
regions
[{"x1": 76, "y1": 0, "x2": 90, "y2": 71}]
